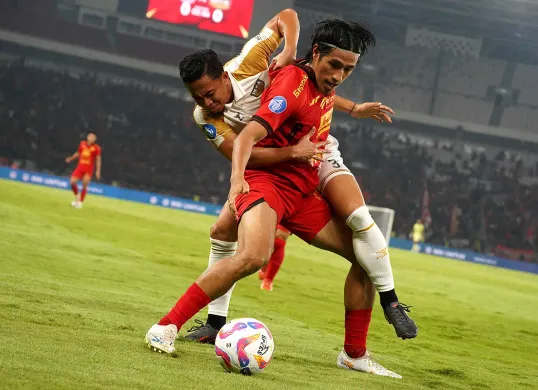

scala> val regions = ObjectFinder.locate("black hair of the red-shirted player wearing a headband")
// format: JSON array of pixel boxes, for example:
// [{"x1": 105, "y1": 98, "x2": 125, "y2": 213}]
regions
[{"x1": 305, "y1": 19, "x2": 376, "y2": 62}]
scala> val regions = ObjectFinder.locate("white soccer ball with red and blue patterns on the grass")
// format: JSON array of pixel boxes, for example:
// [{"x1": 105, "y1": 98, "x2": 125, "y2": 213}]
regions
[{"x1": 215, "y1": 318, "x2": 275, "y2": 375}]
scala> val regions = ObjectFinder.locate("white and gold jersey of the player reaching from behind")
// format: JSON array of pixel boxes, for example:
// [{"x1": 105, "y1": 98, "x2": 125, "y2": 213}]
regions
[{"x1": 193, "y1": 28, "x2": 282, "y2": 149}]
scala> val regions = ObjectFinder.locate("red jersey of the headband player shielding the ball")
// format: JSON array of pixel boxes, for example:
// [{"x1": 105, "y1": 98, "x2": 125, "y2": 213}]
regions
[{"x1": 246, "y1": 63, "x2": 335, "y2": 194}]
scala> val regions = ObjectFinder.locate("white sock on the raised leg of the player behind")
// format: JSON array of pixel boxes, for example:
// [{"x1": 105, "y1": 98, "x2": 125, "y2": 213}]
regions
[{"x1": 346, "y1": 206, "x2": 394, "y2": 292}]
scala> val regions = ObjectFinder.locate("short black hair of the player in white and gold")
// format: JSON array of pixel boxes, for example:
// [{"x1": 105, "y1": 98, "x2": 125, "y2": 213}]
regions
[{"x1": 179, "y1": 49, "x2": 224, "y2": 84}]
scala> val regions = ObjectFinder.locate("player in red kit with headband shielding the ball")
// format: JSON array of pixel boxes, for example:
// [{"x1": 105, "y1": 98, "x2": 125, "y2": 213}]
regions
[{"x1": 146, "y1": 20, "x2": 410, "y2": 378}]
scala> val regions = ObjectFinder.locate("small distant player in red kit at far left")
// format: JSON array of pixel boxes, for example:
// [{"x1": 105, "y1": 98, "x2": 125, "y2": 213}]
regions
[{"x1": 65, "y1": 131, "x2": 101, "y2": 209}]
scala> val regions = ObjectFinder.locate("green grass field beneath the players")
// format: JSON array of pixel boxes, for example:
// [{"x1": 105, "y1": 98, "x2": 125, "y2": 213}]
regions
[{"x1": 0, "y1": 180, "x2": 538, "y2": 390}]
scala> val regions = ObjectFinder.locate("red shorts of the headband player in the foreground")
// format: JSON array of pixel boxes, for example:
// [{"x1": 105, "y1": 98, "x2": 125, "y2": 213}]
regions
[{"x1": 235, "y1": 171, "x2": 332, "y2": 243}]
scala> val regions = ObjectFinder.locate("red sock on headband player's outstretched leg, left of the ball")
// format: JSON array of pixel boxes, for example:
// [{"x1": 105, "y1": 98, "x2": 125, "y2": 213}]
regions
[{"x1": 159, "y1": 283, "x2": 211, "y2": 330}]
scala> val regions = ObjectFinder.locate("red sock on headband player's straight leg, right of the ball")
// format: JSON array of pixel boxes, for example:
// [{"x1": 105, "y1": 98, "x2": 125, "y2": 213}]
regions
[{"x1": 344, "y1": 309, "x2": 372, "y2": 359}]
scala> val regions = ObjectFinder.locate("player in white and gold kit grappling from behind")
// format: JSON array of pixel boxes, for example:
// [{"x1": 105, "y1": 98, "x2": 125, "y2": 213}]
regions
[{"x1": 179, "y1": 10, "x2": 418, "y2": 343}]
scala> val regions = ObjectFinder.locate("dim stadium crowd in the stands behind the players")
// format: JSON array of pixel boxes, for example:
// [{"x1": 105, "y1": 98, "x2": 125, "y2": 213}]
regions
[{"x1": 0, "y1": 64, "x2": 538, "y2": 261}]
